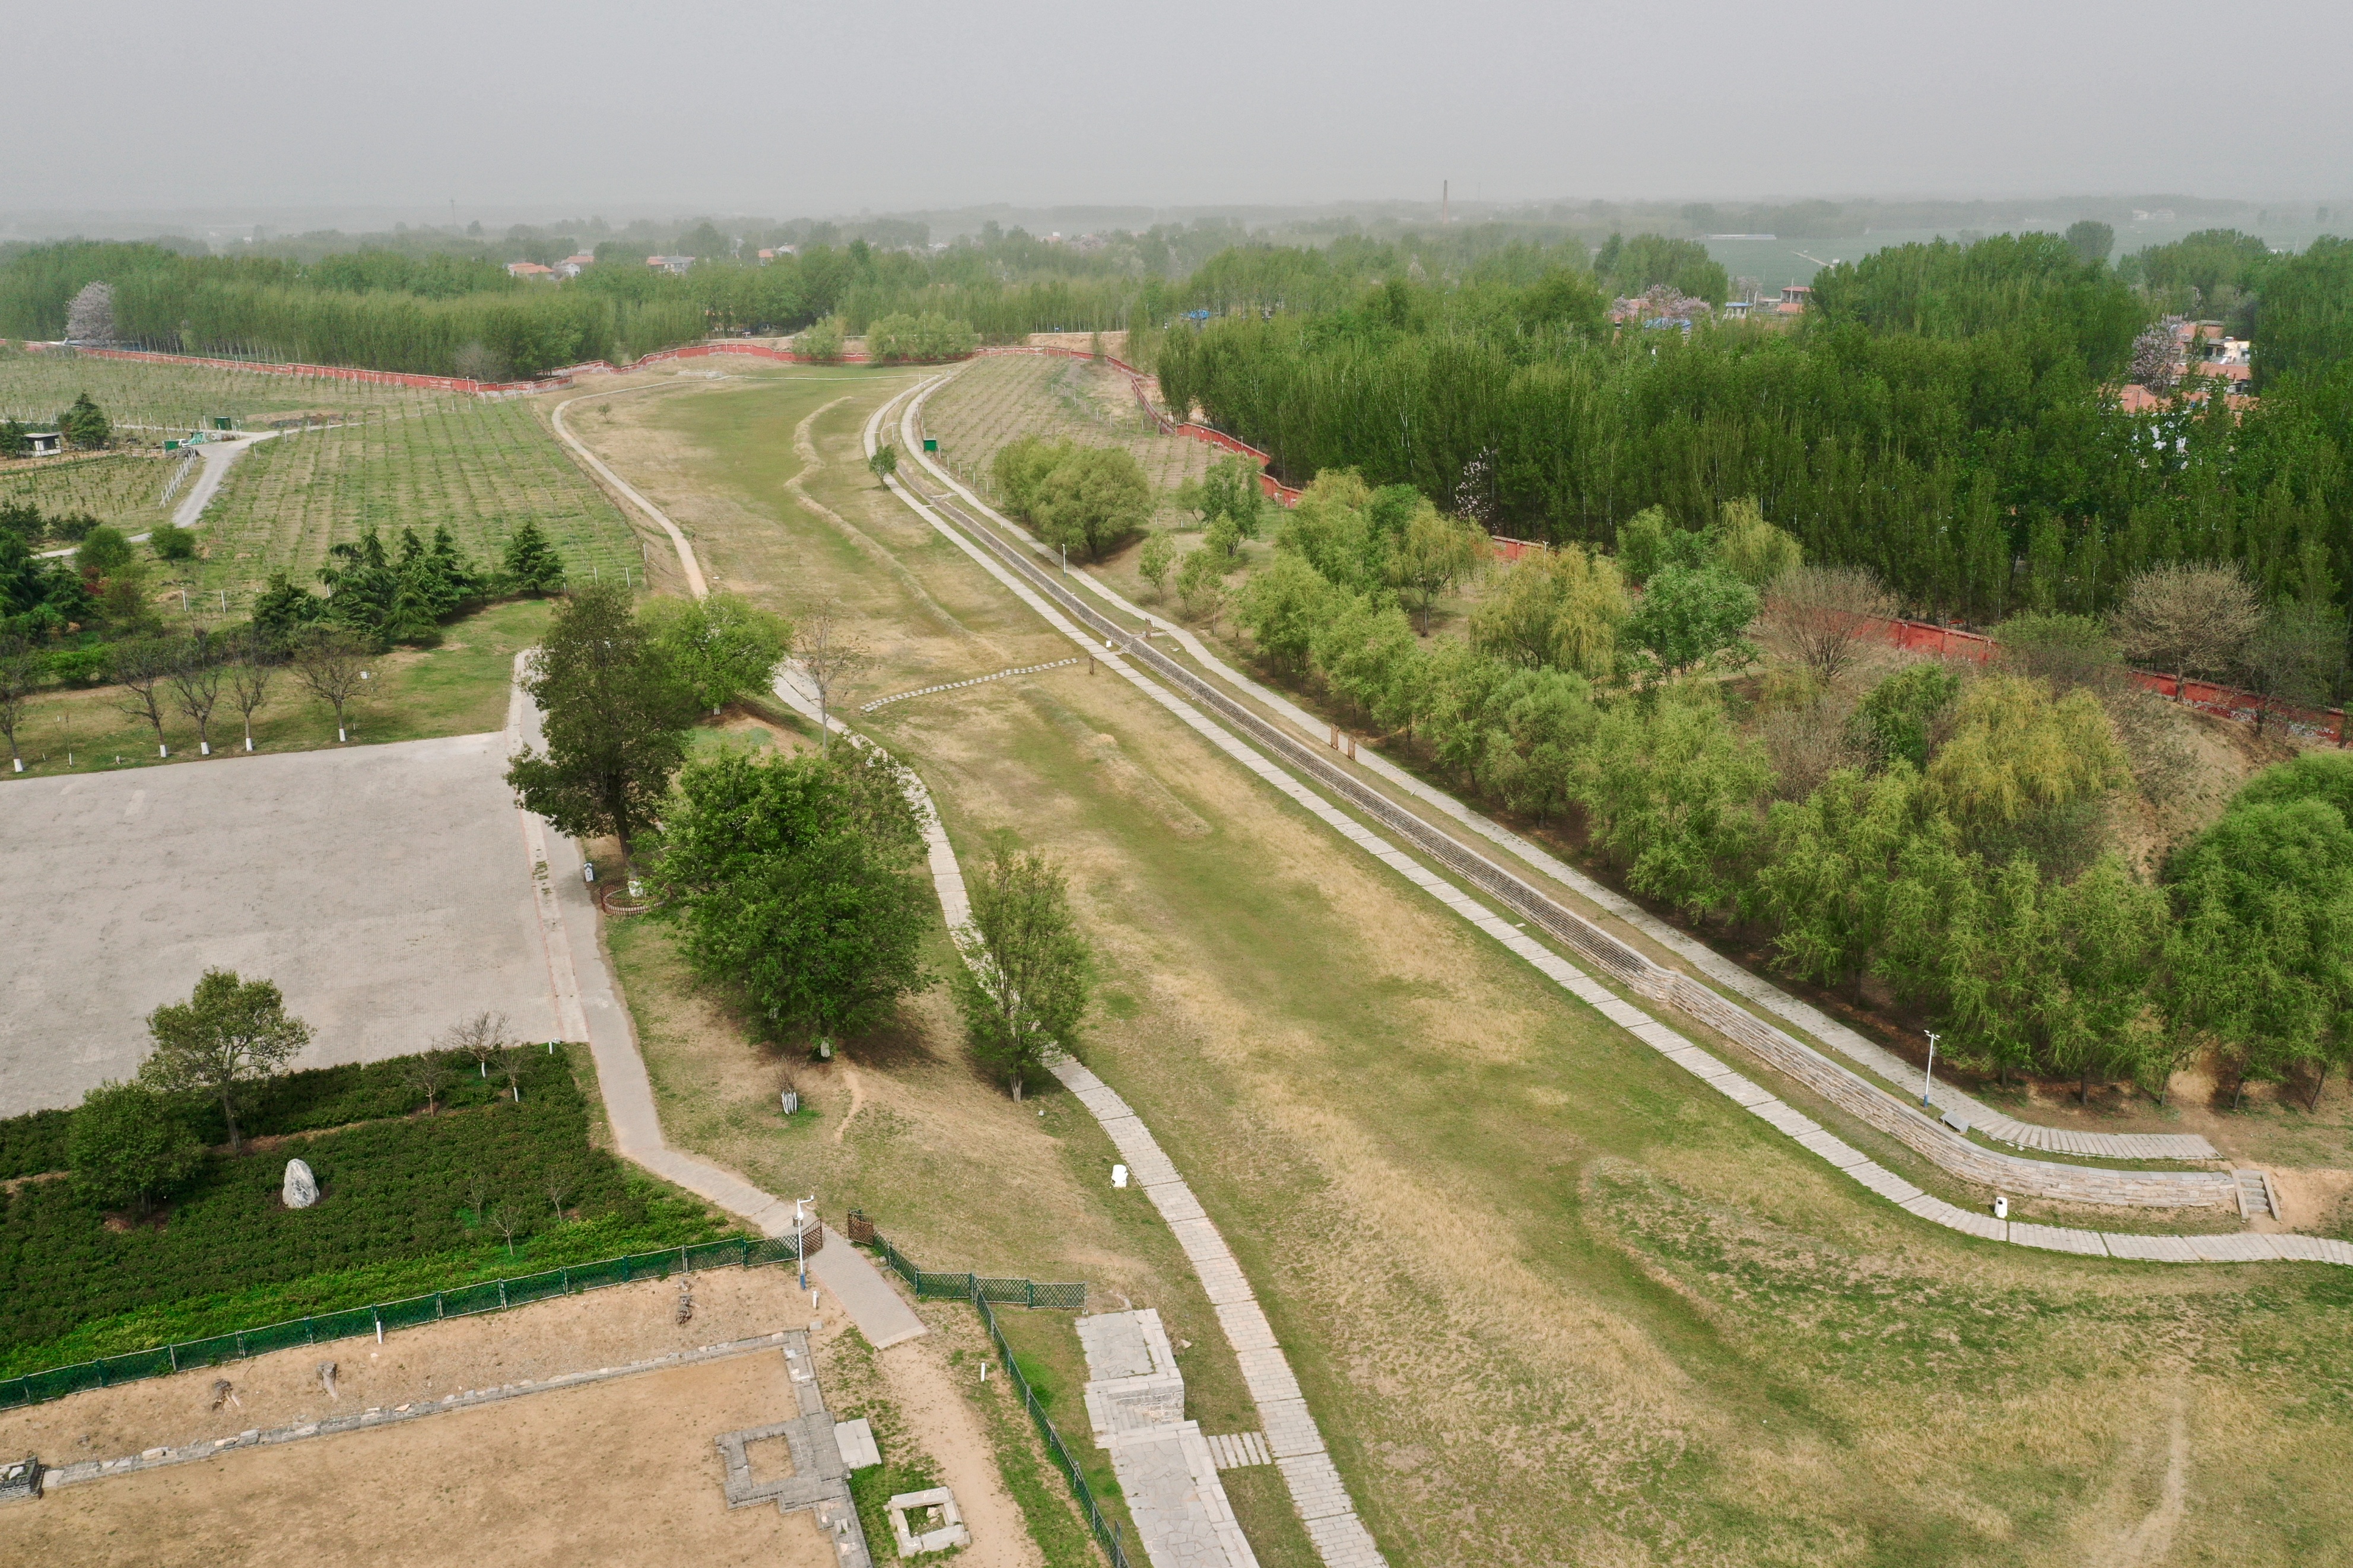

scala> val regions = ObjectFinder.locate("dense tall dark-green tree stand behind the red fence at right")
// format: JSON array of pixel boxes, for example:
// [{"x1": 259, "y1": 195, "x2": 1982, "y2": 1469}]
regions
[{"x1": 1158, "y1": 235, "x2": 2353, "y2": 621}]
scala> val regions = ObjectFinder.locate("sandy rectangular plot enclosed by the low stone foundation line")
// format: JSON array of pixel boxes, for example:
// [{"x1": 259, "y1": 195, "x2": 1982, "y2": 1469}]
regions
[{"x1": 0, "y1": 1351, "x2": 836, "y2": 1568}]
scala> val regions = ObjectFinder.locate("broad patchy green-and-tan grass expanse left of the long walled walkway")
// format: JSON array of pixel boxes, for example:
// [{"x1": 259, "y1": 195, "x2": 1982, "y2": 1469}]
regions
[{"x1": 574, "y1": 371, "x2": 2353, "y2": 1563}]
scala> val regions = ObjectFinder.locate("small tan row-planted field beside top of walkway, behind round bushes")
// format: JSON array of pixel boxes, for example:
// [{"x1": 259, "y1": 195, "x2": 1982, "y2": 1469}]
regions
[{"x1": 925, "y1": 355, "x2": 1224, "y2": 527}]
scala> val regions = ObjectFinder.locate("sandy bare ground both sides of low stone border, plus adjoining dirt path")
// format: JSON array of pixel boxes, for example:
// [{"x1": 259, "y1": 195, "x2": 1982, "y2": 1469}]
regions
[{"x1": 0, "y1": 1270, "x2": 1040, "y2": 1568}]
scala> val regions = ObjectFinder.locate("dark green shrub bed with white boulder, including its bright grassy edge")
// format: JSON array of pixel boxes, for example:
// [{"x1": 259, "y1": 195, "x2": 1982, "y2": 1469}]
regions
[{"x1": 0, "y1": 1055, "x2": 725, "y2": 1375}]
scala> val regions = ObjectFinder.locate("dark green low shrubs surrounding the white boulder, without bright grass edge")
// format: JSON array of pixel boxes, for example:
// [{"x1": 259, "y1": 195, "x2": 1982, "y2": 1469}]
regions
[{"x1": 0, "y1": 1055, "x2": 715, "y2": 1363}]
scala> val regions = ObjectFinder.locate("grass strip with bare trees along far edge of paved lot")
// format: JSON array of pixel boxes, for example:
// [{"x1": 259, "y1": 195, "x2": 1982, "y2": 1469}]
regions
[{"x1": 0, "y1": 599, "x2": 548, "y2": 781}]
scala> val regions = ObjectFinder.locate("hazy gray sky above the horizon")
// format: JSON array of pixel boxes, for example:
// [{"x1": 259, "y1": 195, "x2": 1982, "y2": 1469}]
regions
[{"x1": 0, "y1": 0, "x2": 2353, "y2": 217}]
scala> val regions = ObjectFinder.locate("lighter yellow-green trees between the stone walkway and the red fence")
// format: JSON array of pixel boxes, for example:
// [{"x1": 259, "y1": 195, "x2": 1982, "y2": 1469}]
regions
[{"x1": 1223, "y1": 475, "x2": 2353, "y2": 1093}]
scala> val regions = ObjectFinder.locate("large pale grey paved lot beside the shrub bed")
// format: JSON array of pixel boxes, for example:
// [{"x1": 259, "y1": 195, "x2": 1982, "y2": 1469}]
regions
[{"x1": 0, "y1": 733, "x2": 560, "y2": 1117}]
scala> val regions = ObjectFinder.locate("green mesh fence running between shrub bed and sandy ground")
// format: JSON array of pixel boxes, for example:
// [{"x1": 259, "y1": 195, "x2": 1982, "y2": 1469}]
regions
[{"x1": 0, "y1": 1229, "x2": 814, "y2": 1411}]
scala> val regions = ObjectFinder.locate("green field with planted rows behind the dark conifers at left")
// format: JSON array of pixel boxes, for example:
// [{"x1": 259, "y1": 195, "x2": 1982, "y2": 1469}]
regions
[{"x1": 195, "y1": 395, "x2": 642, "y2": 609}]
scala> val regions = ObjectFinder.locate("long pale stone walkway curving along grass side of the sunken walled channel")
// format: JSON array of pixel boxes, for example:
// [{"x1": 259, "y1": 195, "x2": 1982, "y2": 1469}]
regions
[{"x1": 868, "y1": 381, "x2": 2353, "y2": 1288}]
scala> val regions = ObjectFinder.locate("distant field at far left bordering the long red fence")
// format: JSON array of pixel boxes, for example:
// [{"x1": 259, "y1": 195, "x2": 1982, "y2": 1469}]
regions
[{"x1": 0, "y1": 348, "x2": 437, "y2": 447}]
